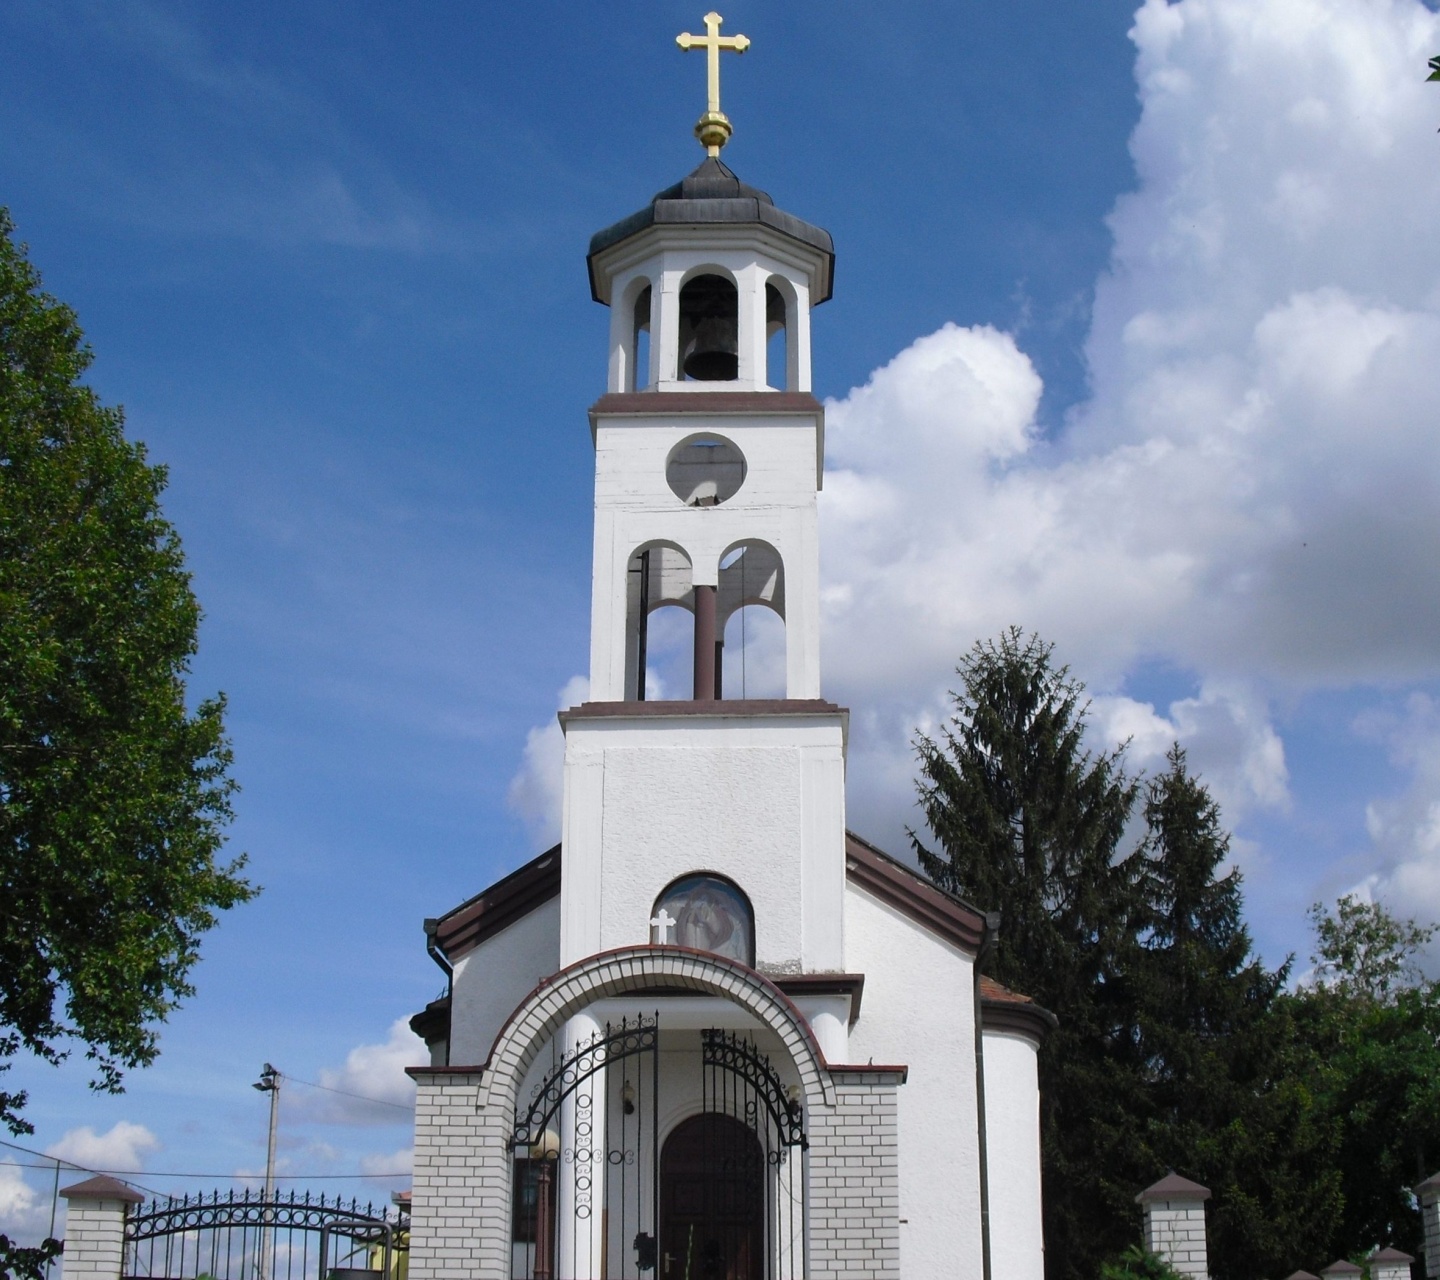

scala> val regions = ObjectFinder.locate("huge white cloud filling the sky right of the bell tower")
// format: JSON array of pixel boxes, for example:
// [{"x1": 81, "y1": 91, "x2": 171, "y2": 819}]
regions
[{"x1": 821, "y1": 0, "x2": 1440, "y2": 881}]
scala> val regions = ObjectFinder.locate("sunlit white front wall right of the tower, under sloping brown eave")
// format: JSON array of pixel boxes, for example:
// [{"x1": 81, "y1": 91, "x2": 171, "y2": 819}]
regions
[{"x1": 845, "y1": 884, "x2": 999, "y2": 1280}]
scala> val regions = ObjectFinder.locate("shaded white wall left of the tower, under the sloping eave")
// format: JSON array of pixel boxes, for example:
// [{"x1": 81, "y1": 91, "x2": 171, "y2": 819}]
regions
[{"x1": 449, "y1": 897, "x2": 560, "y2": 1067}]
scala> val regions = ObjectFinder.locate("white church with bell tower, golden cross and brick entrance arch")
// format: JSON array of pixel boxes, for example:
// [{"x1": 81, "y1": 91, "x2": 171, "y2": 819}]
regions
[{"x1": 409, "y1": 13, "x2": 1054, "y2": 1280}]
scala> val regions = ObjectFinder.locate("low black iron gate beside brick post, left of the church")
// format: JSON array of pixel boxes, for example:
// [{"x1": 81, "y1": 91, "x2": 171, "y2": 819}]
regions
[{"x1": 121, "y1": 1191, "x2": 410, "y2": 1280}]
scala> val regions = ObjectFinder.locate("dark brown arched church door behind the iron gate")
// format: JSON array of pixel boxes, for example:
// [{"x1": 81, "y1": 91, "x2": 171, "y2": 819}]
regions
[{"x1": 658, "y1": 1112, "x2": 765, "y2": 1280}]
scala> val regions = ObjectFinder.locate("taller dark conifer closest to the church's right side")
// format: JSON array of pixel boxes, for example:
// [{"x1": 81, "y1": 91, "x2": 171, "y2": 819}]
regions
[{"x1": 912, "y1": 628, "x2": 1145, "y2": 1280}]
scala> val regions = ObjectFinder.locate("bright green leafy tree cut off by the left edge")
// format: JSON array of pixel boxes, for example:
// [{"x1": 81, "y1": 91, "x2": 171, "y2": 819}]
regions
[{"x1": 0, "y1": 210, "x2": 253, "y2": 1133}]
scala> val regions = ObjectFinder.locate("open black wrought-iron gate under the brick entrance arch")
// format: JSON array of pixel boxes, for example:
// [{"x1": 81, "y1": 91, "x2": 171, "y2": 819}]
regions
[{"x1": 510, "y1": 1014, "x2": 806, "y2": 1280}]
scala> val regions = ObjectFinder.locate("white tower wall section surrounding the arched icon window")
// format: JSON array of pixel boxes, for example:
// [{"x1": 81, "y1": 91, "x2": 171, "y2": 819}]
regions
[{"x1": 560, "y1": 711, "x2": 845, "y2": 973}]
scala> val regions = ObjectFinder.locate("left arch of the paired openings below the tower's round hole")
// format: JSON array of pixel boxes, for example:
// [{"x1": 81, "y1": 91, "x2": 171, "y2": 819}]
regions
[{"x1": 625, "y1": 543, "x2": 694, "y2": 701}]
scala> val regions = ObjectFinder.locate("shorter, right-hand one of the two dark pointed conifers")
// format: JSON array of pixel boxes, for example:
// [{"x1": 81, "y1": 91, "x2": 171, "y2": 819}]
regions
[{"x1": 1130, "y1": 744, "x2": 1341, "y2": 1277}]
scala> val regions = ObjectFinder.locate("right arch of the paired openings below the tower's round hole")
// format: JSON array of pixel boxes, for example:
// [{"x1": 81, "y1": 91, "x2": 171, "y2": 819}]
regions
[{"x1": 717, "y1": 538, "x2": 788, "y2": 698}]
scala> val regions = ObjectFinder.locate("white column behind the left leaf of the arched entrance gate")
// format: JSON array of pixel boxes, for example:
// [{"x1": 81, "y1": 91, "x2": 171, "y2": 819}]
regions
[{"x1": 554, "y1": 1014, "x2": 606, "y2": 1280}]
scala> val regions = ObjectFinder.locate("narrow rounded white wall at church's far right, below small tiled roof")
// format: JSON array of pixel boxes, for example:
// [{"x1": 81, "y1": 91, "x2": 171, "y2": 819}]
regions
[{"x1": 985, "y1": 1031, "x2": 1045, "y2": 1280}]
